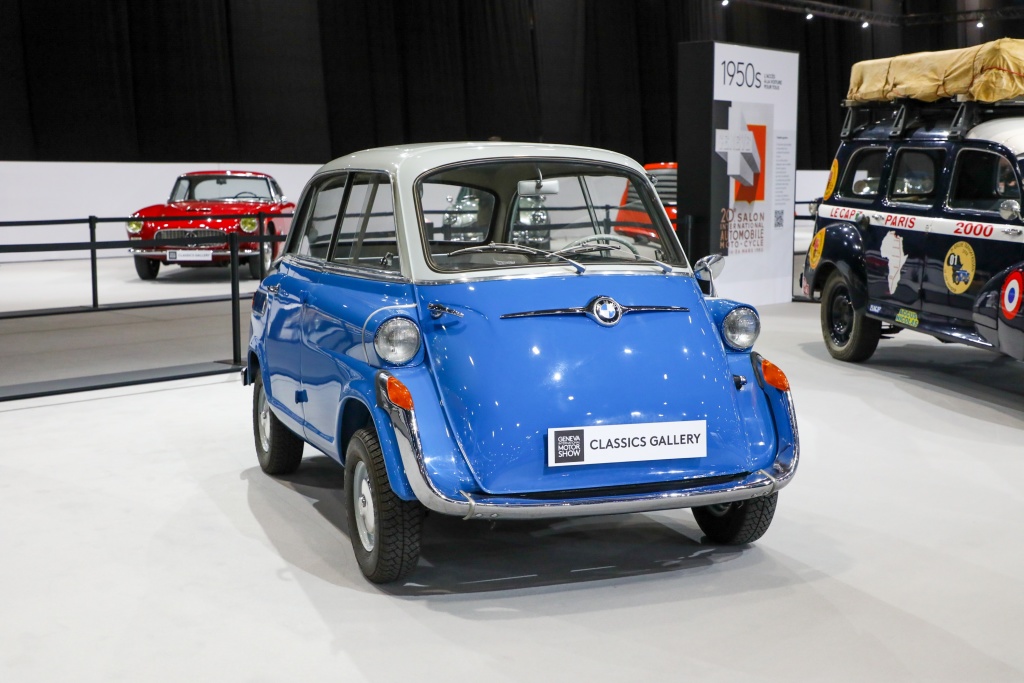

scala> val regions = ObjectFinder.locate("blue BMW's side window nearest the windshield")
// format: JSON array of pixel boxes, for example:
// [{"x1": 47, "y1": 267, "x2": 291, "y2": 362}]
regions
[{"x1": 332, "y1": 173, "x2": 399, "y2": 271}]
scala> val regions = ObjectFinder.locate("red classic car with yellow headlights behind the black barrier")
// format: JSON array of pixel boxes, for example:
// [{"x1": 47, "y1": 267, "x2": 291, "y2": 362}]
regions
[{"x1": 127, "y1": 171, "x2": 295, "y2": 280}]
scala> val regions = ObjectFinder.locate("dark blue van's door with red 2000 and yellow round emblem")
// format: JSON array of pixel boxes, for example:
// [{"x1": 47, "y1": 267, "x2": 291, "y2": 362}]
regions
[{"x1": 924, "y1": 142, "x2": 1024, "y2": 326}]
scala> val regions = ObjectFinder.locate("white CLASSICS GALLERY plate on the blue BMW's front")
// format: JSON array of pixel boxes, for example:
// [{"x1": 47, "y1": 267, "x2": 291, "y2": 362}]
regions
[{"x1": 548, "y1": 420, "x2": 708, "y2": 467}]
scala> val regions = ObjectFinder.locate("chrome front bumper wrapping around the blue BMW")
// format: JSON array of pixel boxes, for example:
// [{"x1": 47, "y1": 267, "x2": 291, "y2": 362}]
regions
[{"x1": 376, "y1": 371, "x2": 800, "y2": 519}]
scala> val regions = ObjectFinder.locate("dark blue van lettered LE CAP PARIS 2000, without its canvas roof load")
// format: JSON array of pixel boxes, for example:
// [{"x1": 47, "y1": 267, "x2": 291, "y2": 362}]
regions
[{"x1": 803, "y1": 99, "x2": 1024, "y2": 361}]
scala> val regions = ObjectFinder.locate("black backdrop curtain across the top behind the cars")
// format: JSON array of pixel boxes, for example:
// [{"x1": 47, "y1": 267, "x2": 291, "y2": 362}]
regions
[{"x1": 0, "y1": 0, "x2": 991, "y2": 169}]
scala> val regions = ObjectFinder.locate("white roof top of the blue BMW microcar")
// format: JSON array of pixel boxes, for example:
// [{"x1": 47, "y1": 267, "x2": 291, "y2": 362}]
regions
[{"x1": 316, "y1": 142, "x2": 644, "y2": 181}]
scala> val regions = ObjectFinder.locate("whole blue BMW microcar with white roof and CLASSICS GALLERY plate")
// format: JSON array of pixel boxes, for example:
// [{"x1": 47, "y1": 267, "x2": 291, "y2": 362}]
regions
[{"x1": 245, "y1": 142, "x2": 799, "y2": 583}]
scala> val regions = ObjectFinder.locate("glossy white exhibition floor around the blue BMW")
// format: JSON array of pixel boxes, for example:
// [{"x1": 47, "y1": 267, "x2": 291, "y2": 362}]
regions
[{"x1": 0, "y1": 304, "x2": 1024, "y2": 683}]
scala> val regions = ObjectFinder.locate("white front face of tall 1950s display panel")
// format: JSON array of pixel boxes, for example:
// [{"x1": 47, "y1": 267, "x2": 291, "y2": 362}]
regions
[{"x1": 712, "y1": 43, "x2": 800, "y2": 303}]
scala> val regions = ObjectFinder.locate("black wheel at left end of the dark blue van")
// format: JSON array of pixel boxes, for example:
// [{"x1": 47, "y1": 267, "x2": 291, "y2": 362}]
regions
[{"x1": 821, "y1": 270, "x2": 882, "y2": 362}]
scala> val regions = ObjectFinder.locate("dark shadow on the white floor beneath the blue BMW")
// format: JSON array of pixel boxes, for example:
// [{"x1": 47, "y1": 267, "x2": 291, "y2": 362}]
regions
[{"x1": 256, "y1": 456, "x2": 751, "y2": 597}]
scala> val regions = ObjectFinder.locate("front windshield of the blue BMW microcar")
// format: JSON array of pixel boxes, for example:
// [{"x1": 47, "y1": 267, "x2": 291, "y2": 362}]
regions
[{"x1": 417, "y1": 160, "x2": 686, "y2": 271}]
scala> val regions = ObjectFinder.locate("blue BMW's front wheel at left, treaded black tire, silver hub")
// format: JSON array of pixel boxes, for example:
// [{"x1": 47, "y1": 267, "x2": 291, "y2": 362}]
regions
[{"x1": 345, "y1": 428, "x2": 424, "y2": 584}]
